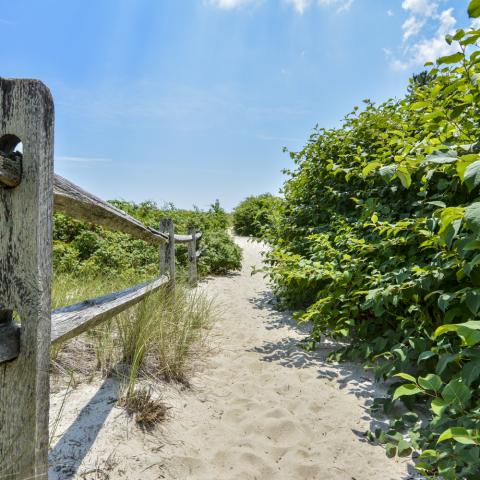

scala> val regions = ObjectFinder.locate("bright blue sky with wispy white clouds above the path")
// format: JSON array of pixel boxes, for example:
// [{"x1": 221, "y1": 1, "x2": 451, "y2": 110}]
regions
[{"x1": 0, "y1": 0, "x2": 469, "y2": 209}]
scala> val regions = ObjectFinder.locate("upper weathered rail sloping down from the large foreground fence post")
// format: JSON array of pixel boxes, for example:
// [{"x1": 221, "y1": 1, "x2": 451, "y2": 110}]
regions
[{"x1": 54, "y1": 175, "x2": 168, "y2": 245}]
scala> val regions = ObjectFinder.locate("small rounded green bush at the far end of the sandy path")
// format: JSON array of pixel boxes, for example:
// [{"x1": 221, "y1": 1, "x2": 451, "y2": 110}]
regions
[{"x1": 233, "y1": 193, "x2": 282, "y2": 237}]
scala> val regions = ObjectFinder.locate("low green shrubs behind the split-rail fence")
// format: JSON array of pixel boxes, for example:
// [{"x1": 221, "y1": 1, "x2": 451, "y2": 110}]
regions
[{"x1": 53, "y1": 201, "x2": 241, "y2": 278}]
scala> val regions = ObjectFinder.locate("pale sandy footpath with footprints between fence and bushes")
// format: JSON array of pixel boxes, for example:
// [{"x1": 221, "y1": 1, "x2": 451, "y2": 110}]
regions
[{"x1": 50, "y1": 237, "x2": 415, "y2": 480}]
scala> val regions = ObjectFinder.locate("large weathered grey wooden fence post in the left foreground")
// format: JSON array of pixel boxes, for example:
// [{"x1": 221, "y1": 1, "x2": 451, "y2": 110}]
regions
[{"x1": 0, "y1": 78, "x2": 53, "y2": 480}]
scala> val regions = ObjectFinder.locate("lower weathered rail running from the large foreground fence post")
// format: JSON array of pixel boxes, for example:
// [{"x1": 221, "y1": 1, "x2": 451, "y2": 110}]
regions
[{"x1": 51, "y1": 276, "x2": 168, "y2": 343}]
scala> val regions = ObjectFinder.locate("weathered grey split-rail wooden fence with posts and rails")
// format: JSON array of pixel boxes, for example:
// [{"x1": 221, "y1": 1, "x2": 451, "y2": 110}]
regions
[{"x1": 0, "y1": 78, "x2": 202, "y2": 480}]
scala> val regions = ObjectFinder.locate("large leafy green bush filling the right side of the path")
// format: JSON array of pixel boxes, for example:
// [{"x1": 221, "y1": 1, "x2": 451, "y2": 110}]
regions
[{"x1": 265, "y1": 13, "x2": 480, "y2": 480}]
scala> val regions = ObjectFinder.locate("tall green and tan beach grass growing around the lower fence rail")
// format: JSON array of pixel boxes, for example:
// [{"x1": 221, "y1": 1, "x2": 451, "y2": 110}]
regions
[{"x1": 52, "y1": 275, "x2": 216, "y2": 426}]
